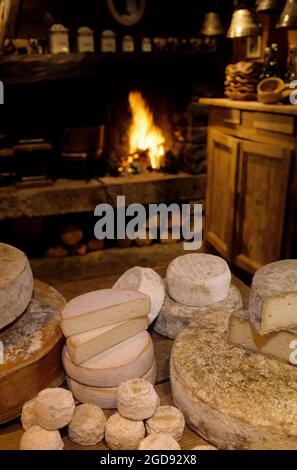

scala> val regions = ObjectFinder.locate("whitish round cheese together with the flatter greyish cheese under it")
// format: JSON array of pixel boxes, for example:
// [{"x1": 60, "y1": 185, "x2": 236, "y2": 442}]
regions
[{"x1": 154, "y1": 253, "x2": 242, "y2": 339}]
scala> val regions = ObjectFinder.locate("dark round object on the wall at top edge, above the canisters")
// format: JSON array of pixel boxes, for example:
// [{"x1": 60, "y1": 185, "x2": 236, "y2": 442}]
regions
[{"x1": 107, "y1": 0, "x2": 146, "y2": 26}]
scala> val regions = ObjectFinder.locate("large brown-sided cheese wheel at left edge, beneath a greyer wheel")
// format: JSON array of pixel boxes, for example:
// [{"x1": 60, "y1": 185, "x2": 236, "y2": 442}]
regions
[{"x1": 0, "y1": 281, "x2": 65, "y2": 424}]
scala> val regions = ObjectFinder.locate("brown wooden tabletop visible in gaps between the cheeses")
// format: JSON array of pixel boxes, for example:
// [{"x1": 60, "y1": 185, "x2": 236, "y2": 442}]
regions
[{"x1": 0, "y1": 268, "x2": 249, "y2": 450}]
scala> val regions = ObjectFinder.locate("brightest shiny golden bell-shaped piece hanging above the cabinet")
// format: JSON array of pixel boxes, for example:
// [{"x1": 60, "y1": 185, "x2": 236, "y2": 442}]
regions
[{"x1": 227, "y1": 8, "x2": 261, "y2": 39}]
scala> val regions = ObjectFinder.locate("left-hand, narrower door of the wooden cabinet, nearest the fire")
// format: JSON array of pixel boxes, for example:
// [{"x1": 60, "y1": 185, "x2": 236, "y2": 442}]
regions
[{"x1": 206, "y1": 130, "x2": 239, "y2": 261}]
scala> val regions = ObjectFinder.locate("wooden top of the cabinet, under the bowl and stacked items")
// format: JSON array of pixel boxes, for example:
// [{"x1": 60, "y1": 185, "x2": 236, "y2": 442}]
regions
[{"x1": 199, "y1": 97, "x2": 297, "y2": 116}]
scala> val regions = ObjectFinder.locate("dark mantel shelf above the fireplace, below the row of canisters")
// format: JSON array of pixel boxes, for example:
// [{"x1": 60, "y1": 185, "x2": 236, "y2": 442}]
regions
[{"x1": 0, "y1": 52, "x2": 220, "y2": 85}]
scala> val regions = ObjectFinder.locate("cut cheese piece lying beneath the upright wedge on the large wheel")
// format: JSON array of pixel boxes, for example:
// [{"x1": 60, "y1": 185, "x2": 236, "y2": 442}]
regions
[{"x1": 228, "y1": 309, "x2": 297, "y2": 365}]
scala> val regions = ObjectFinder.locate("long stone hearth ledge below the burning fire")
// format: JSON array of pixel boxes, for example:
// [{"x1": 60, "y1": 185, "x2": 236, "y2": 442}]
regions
[{"x1": 0, "y1": 173, "x2": 206, "y2": 220}]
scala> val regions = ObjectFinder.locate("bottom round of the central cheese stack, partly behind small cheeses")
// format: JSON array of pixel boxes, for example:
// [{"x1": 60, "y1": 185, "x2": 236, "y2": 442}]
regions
[{"x1": 66, "y1": 361, "x2": 157, "y2": 410}]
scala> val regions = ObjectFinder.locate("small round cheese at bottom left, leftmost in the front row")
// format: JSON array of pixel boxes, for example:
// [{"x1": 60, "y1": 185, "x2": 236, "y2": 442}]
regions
[{"x1": 20, "y1": 426, "x2": 64, "y2": 450}]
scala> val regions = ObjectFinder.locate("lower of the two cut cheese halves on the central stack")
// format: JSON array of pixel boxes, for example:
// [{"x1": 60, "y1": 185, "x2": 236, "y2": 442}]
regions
[{"x1": 66, "y1": 316, "x2": 147, "y2": 365}]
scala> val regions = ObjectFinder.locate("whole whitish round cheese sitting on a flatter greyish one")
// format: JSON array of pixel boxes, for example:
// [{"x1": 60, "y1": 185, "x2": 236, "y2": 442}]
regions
[{"x1": 166, "y1": 253, "x2": 231, "y2": 307}]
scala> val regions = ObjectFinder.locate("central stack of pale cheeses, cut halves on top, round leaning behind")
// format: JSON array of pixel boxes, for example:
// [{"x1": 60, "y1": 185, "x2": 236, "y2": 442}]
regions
[{"x1": 61, "y1": 268, "x2": 165, "y2": 409}]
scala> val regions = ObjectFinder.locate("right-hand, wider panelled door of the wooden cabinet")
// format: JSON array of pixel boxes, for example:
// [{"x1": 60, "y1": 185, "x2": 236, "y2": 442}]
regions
[{"x1": 234, "y1": 141, "x2": 292, "y2": 273}]
